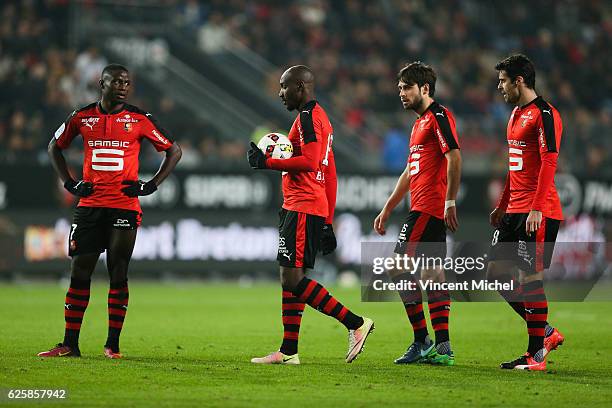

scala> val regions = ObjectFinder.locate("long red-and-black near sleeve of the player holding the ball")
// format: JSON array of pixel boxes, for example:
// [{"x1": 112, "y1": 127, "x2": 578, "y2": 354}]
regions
[{"x1": 266, "y1": 109, "x2": 323, "y2": 172}]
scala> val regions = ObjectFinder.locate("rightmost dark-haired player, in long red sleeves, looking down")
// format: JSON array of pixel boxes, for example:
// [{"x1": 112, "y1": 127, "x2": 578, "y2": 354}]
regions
[{"x1": 487, "y1": 54, "x2": 564, "y2": 370}]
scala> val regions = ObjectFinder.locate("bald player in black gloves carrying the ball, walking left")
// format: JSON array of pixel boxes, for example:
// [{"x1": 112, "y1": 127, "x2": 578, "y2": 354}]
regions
[{"x1": 248, "y1": 65, "x2": 374, "y2": 364}]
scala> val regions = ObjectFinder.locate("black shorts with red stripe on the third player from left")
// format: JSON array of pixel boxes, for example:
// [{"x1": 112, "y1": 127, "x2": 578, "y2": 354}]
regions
[{"x1": 395, "y1": 211, "x2": 446, "y2": 257}]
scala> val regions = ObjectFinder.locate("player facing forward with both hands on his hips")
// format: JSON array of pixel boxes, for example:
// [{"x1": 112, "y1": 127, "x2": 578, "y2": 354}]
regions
[{"x1": 38, "y1": 64, "x2": 181, "y2": 358}]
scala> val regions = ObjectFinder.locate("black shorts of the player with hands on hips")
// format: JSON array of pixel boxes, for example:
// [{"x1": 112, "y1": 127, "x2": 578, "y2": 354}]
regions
[{"x1": 68, "y1": 207, "x2": 142, "y2": 256}]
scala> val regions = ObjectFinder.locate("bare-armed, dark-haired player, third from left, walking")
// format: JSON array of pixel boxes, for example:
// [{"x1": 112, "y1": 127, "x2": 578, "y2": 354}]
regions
[{"x1": 374, "y1": 62, "x2": 461, "y2": 365}]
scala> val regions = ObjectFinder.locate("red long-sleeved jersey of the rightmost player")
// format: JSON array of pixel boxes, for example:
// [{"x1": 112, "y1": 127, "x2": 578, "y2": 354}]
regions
[{"x1": 506, "y1": 97, "x2": 563, "y2": 220}]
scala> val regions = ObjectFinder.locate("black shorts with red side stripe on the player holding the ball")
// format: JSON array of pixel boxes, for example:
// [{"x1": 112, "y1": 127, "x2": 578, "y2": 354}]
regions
[{"x1": 276, "y1": 208, "x2": 325, "y2": 269}]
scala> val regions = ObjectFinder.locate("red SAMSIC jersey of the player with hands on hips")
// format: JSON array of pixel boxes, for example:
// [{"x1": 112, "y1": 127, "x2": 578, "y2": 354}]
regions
[{"x1": 55, "y1": 103, "x2": 172, "y2": 211}]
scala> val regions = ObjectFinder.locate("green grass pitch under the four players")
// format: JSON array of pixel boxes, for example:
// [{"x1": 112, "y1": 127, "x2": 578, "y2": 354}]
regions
[{"x1": 0, "y1": 281, "x2": 612, "y2": 408}]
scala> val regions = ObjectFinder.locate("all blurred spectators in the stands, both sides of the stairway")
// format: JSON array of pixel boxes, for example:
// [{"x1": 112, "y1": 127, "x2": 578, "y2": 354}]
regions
[{"x1": 0, "y1": 0, "x2": 612, "y2": 175}]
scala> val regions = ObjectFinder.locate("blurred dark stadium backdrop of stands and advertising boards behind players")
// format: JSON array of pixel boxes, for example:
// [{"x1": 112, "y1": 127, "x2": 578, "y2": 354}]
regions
[{"x1": 0, "y1": 0, "x2": 612, "y2": 281}]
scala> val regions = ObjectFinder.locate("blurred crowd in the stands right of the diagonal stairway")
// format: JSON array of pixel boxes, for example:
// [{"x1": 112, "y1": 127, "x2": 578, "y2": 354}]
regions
[{"x1": 179, "y1": 0, "x2": 612, "y2": 174}]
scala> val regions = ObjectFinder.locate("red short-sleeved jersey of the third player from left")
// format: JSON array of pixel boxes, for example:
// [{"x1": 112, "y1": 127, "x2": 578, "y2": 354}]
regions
[{"x1": 408, "y1": 101, "x2": 459, "y2": 219}]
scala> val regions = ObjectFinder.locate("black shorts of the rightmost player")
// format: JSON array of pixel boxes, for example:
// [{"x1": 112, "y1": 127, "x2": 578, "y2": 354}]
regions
[{"x1": 489, "y1": 213, "x2": 561, "y2": 272}]
